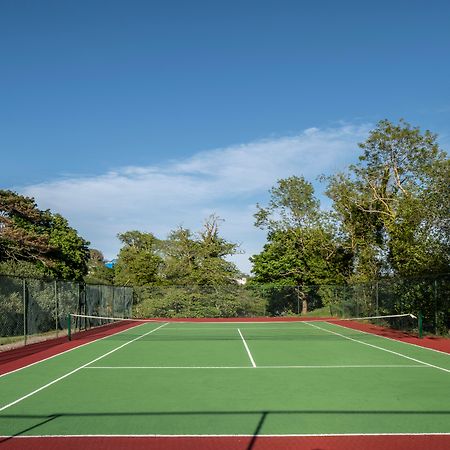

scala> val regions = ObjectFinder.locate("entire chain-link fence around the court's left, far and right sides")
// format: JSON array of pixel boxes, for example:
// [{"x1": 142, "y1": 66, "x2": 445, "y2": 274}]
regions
[{"x1": 0, "y1": 274, "x2": 450, "y2": 349}]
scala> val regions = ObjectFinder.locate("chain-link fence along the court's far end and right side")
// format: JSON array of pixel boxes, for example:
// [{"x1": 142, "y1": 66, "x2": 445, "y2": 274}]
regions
[{"x1": 133, "y1": 274, "x2": 450, "y2": 335}]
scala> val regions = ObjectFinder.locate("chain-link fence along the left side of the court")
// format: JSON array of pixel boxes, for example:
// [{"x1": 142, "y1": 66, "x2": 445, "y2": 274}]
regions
[{"x1": 0, "y1": 275, "x2": 133, "y2": 349}]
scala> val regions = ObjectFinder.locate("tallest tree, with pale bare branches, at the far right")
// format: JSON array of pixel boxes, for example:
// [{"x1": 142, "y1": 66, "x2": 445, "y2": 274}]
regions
[{"x1": 327, "y1": 120, "x2": 449, "y2": 280}]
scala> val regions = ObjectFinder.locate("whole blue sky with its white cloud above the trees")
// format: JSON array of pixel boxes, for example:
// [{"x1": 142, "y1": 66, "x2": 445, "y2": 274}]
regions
[{"x1": 0, "y1": 0, "x2": 450, "y2": 272}]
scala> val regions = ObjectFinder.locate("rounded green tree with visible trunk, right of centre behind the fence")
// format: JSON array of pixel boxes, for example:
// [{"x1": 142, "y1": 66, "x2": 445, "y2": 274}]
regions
[{"x1": 250, "y1": 177, "x2": 351, "y2": 312}]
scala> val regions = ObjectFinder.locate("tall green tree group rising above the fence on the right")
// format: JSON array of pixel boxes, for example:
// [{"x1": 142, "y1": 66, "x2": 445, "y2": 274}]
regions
[{"x1": 252, "y1": 120, "x2": 450, "y2": 285}]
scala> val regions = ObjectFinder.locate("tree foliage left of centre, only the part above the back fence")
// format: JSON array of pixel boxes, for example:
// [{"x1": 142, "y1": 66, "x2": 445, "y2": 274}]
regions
[{"x1": 115, "y1": 216, "x2": 240, "y2": 286}]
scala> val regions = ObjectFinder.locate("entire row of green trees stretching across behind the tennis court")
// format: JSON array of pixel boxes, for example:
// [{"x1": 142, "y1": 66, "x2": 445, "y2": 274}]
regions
[{"x1": 0, "y1": 120, "x2": 450, "y2": 315}]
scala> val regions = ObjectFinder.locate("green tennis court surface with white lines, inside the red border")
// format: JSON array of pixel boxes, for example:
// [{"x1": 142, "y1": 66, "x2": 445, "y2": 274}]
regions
[{"x1": 0, "y1": 322, "x2": 450, "y2": 436}]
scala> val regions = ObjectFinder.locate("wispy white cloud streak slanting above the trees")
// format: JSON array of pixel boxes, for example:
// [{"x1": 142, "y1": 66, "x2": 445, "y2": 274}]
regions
[{"x1": 20, "y1": 121, "x2": 369, "y2": 272}]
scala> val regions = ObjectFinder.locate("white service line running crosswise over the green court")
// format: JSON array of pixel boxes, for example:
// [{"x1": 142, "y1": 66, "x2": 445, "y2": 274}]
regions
[{"x1": 85, "y1": 364, "x2": 429, "y2": 370}]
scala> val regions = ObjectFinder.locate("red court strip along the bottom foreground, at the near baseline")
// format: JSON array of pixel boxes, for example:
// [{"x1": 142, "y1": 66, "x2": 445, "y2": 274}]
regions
[{"x1": 0, "y1": 433, "x2": 450, "y2": 450}]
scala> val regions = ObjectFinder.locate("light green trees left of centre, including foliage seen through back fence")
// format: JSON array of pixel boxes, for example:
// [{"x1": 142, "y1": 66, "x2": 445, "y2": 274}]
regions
[{"x1": 126, "y1": 216, "x2": 248, "y2": 317}]
